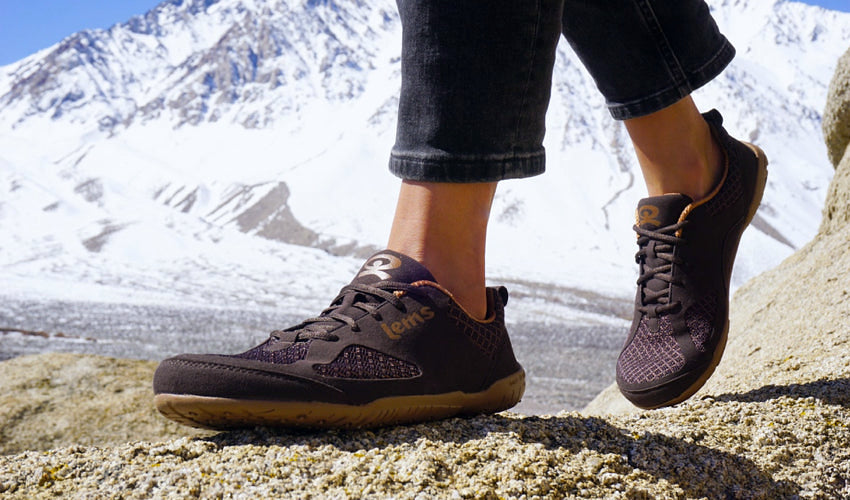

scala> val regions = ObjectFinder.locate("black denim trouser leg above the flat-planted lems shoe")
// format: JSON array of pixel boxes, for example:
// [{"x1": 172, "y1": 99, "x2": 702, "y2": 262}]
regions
[{"x1": 390, "y1": 0, "x2": 563, "y2": 183}]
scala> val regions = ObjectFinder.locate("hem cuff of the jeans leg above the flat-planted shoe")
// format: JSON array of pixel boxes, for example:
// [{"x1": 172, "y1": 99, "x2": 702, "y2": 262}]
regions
[{"x1": 390, "y1": 148, "x2": 546, "y2": 183}]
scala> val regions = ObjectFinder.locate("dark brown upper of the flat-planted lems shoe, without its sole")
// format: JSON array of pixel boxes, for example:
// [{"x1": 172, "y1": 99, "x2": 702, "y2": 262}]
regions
[{"x1": 154, "y1": 251, "x2": 521, "y2": 405}]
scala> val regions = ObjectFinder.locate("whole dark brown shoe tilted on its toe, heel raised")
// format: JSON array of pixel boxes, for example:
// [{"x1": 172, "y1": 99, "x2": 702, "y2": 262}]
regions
[{"x1": 617, "y1": 111, "x2": 767, "y2": 409}]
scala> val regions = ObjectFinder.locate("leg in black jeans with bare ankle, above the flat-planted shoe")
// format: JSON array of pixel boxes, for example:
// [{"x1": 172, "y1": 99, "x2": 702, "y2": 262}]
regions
[{"x1": 389, "y1": 0, "x2": 561, "y2": 318}]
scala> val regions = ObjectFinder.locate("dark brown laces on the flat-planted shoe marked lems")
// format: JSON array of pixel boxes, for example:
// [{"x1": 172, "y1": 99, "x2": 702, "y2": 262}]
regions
[{"x1": 271, "y1": 281, "x2": 410, "y2": 342}]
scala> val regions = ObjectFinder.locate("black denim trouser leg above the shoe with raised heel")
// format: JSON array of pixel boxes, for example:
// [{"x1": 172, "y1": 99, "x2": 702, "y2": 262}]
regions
[{"x1": 563, "y1": 0, "x2": 735, "y2": 120}]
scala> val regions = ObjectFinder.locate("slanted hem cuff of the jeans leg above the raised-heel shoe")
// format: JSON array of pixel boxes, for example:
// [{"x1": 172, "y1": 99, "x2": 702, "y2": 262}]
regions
[{"x1": 606, "y1": 39, "x2": 735, "y2": 120}]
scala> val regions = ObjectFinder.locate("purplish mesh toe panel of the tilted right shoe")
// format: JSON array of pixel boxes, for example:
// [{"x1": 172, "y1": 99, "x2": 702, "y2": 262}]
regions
[{"x1": 617, "y1": 316, "x2": 685, "y2": 384}]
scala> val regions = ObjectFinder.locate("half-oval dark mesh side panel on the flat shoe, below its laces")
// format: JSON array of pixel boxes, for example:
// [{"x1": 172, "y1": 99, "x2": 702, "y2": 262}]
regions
[{"x1": 313, "y1": 345, "x2": 422, "y2": 379}]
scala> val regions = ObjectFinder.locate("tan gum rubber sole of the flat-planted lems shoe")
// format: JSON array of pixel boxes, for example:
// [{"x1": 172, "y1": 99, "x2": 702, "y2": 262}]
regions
[{"x1": 154, "y1": 369, "x2": 525, "y2": 430}]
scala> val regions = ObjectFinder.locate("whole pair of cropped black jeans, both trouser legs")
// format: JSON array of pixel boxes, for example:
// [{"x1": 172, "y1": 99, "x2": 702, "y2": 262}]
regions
[{"x1": 390, "y1": 0, "x2": 735, "y2": 182}]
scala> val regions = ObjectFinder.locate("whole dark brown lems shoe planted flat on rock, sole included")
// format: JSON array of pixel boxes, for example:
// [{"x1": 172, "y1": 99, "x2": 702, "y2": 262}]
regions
[{"x1": 154, "y1": 250, "x2": 525, "y2": 429}]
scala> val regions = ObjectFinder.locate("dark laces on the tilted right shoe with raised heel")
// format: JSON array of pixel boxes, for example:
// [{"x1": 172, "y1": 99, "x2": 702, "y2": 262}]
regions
[{"x1": 632, "y1": 221, "x2": 688, "y2": 318}]
